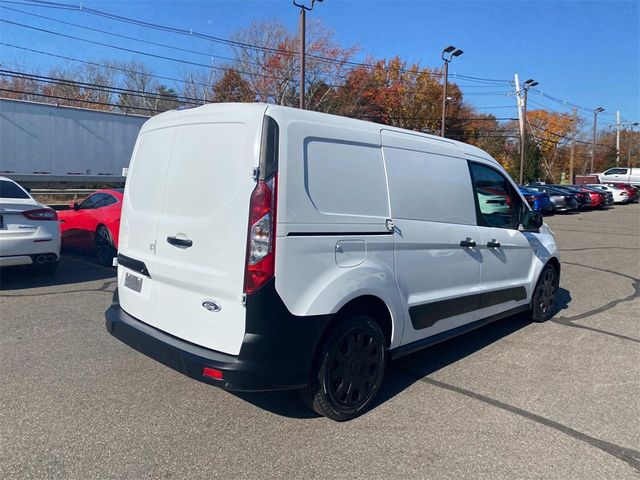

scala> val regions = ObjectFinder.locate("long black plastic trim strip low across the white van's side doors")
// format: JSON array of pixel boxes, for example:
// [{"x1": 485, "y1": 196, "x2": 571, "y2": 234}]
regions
[{"x1": 409, "y1": 287, "x2": 527, "y2": 330}]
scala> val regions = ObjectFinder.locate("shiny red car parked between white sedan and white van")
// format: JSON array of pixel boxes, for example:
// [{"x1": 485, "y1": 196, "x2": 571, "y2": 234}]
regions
[{"x1": 58, "y1": 188, "x2": 123, "y2": 266}]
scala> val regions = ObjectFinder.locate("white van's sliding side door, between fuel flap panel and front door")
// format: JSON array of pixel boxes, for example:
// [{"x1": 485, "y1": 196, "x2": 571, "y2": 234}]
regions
[{"x1": 382, "y1": 130, "x2": 481, "y2": 344}]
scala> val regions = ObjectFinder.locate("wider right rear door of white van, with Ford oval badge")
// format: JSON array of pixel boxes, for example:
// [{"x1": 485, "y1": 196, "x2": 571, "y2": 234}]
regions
[{"x1": 152, "y1": 105, "x2": 266, "y2": 355}]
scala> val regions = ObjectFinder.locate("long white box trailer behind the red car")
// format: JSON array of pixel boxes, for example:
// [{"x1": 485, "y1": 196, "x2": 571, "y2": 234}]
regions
[{"x1": 0, "y1": 98, "x2": 148, "y2": 184}]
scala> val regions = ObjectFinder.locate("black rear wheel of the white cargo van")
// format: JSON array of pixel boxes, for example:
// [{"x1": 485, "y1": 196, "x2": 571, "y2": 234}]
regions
[{"x1": 300, "y1": 315, "x2": 387, "y2": 422}]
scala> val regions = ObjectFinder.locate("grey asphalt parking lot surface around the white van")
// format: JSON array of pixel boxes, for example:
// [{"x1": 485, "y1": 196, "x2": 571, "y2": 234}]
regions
[{"x1": 0, "y1": 204, "x2": 640, "y2": 479}]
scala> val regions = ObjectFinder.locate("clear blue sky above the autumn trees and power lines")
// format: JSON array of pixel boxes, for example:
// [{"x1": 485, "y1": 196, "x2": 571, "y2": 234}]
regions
[{"x1": 0, "y1": 0, "x2": 640, "y2": 128}]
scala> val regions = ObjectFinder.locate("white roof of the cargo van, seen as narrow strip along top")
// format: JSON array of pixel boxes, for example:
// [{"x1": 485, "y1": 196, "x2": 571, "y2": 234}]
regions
[{"x1": 142, "y1": 103, "x2": 498, "y2": 164}]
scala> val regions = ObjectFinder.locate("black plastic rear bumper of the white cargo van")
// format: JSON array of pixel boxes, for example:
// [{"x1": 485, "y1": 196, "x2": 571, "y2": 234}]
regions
[{"x1": 105, "y1": 285, "x2": 329, "y2": 391}]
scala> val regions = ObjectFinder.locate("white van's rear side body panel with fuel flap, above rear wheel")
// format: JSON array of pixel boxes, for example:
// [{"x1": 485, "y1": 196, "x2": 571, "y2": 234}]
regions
[{"x1": 267, "y1": 107, "x2": 404, "y2": 348}]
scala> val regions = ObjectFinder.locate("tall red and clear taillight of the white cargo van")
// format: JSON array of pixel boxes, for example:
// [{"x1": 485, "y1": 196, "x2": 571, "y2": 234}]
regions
[{"x1": 244, "y1": 175, "x2": 277, "y2": 293}]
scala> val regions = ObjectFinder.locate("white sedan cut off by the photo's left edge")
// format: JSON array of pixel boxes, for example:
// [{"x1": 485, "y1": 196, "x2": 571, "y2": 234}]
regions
[{"x1": 0, "y1": 177, "x2": 60, "y2": 273}]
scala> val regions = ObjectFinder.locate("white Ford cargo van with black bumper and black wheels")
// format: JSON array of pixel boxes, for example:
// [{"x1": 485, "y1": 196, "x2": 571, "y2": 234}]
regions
[{"x1": 106, "y1": 104, "x2": 560, "y2": 420}]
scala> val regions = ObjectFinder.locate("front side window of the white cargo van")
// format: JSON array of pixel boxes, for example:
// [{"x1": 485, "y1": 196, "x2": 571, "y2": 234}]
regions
[{"x1": 469, "y1": 162, "x2": 522, "y2": 229}]
